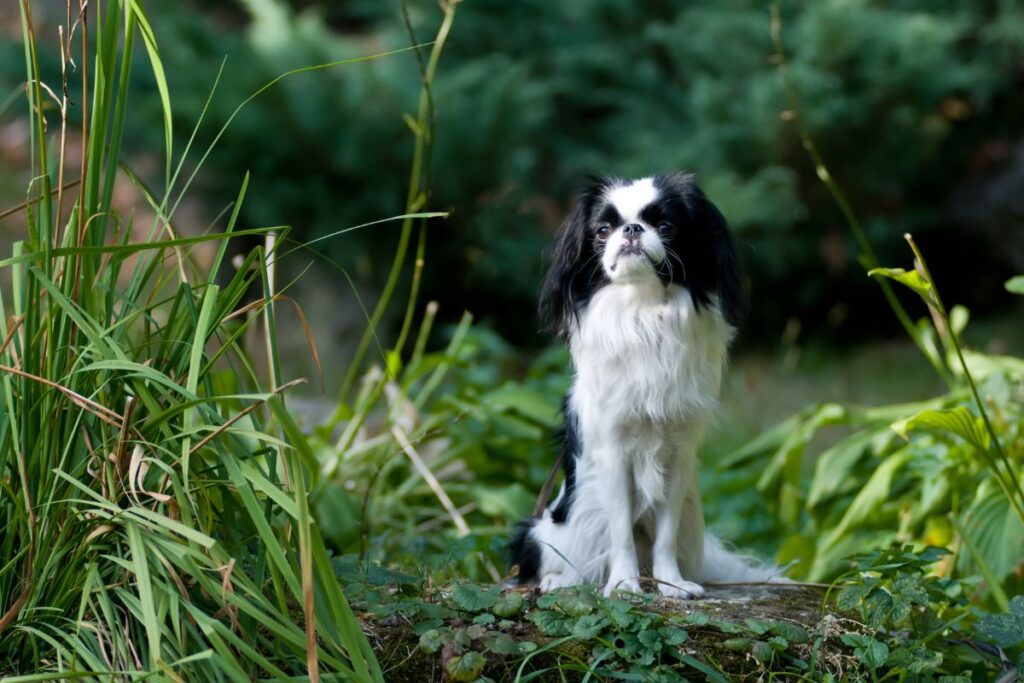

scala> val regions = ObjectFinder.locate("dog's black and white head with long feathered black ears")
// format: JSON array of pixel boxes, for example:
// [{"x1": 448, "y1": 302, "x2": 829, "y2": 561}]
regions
[{"x1": 541, "y1": 173, "x2": 745, "y2": 335}]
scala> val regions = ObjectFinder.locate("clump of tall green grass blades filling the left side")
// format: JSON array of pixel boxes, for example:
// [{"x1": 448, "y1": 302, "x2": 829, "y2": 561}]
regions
[{"x1": 0, "y1": 0, "x2": 448, "y2": 681}]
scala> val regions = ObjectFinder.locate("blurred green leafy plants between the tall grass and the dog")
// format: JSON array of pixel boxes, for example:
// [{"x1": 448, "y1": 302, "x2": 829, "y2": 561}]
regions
[{"x1": 307, "y1": 325, "x2": 568, "y2": 579}]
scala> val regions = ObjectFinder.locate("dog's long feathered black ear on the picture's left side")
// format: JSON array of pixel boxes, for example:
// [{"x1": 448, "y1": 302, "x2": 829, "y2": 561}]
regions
[{"x1": 539, "y1": 182, "x2": 601, "y2": 337}]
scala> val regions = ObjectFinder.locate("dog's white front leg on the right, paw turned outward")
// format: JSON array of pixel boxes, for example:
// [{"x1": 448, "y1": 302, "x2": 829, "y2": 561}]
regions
[{"x1": 651, "y1": 447, "x2": 703, "y2": 599}]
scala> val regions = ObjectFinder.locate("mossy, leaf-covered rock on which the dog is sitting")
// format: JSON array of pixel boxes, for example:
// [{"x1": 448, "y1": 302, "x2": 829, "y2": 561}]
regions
[{"x1": 362, "y1": 584, "x2": 854, "y2": 683}]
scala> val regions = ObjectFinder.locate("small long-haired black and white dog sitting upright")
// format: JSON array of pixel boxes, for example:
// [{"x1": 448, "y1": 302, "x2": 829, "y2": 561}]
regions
[{"x1": 511, "y1": 173, "x2": 784, "y2": 598}]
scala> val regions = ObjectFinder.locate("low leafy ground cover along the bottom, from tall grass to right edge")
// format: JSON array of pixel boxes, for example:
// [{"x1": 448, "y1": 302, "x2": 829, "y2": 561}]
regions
[{"x1": 345, "y1": 557, "x2": 1024, "y2": 681}]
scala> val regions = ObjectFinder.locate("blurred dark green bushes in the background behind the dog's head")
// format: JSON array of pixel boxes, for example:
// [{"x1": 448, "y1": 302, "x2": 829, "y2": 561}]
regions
[{"x1": 0, "y1": 0, "x2": 1024, "y2": 360}]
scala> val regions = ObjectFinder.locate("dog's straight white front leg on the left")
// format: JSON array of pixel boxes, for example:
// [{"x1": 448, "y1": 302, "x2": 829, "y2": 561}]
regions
[{"x1": 595, "y1": 446, "x2": 640, "y2": 595}]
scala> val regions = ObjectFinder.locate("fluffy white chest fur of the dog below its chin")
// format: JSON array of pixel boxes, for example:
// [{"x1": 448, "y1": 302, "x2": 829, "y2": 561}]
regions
[{"x1": 569, "y1": 282, "x2": 733, "y2": 426}]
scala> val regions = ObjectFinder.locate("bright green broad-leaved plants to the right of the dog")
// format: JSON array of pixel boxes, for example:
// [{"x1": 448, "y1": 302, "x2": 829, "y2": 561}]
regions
[{"x1": 725, "y1": 260, "x2": 1024, "y2": 603}]
